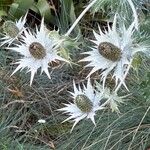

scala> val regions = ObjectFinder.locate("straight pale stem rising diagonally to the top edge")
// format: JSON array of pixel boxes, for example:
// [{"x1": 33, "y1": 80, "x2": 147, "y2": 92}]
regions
[{"x1": 65, "y1": 0, "x2": 97, "y2": 36}]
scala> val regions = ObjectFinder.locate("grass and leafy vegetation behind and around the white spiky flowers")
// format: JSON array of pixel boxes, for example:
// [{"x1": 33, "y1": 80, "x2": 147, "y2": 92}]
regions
[{"x1": 0, "y1": 0, "x2": 150, "y2": 150}]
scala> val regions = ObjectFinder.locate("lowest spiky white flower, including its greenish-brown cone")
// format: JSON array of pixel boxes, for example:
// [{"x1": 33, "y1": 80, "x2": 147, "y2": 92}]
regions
[{"x1": 59, "y1": 79, "x2": 103, "y2": 131}]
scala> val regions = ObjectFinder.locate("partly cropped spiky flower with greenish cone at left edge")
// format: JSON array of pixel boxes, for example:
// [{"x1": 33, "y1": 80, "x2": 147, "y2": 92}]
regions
[{"x1": 0, "y1": 13, "x2": 27, "y2": 46}]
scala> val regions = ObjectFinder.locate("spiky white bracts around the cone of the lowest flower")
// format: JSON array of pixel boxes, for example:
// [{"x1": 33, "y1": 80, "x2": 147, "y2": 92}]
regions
[{"x1": 59, "y1": 79, "x2": 103, "y2": 131}]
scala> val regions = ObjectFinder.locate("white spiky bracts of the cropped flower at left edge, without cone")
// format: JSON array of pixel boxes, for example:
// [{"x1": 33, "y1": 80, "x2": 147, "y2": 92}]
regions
[{"x1": 0, "y1": 13, "x2": 27, "y2": 46}]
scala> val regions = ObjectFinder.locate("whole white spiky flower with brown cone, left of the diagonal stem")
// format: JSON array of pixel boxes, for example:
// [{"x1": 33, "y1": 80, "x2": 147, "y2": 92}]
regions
[{"x1": 8, "y1": 19, "x2": 68, "y2": 85}]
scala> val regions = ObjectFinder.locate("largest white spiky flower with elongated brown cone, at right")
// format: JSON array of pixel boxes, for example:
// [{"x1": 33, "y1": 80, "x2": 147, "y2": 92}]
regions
[{"x1": 80, "y1": 15, "x2": 144, "y2": 88}]
